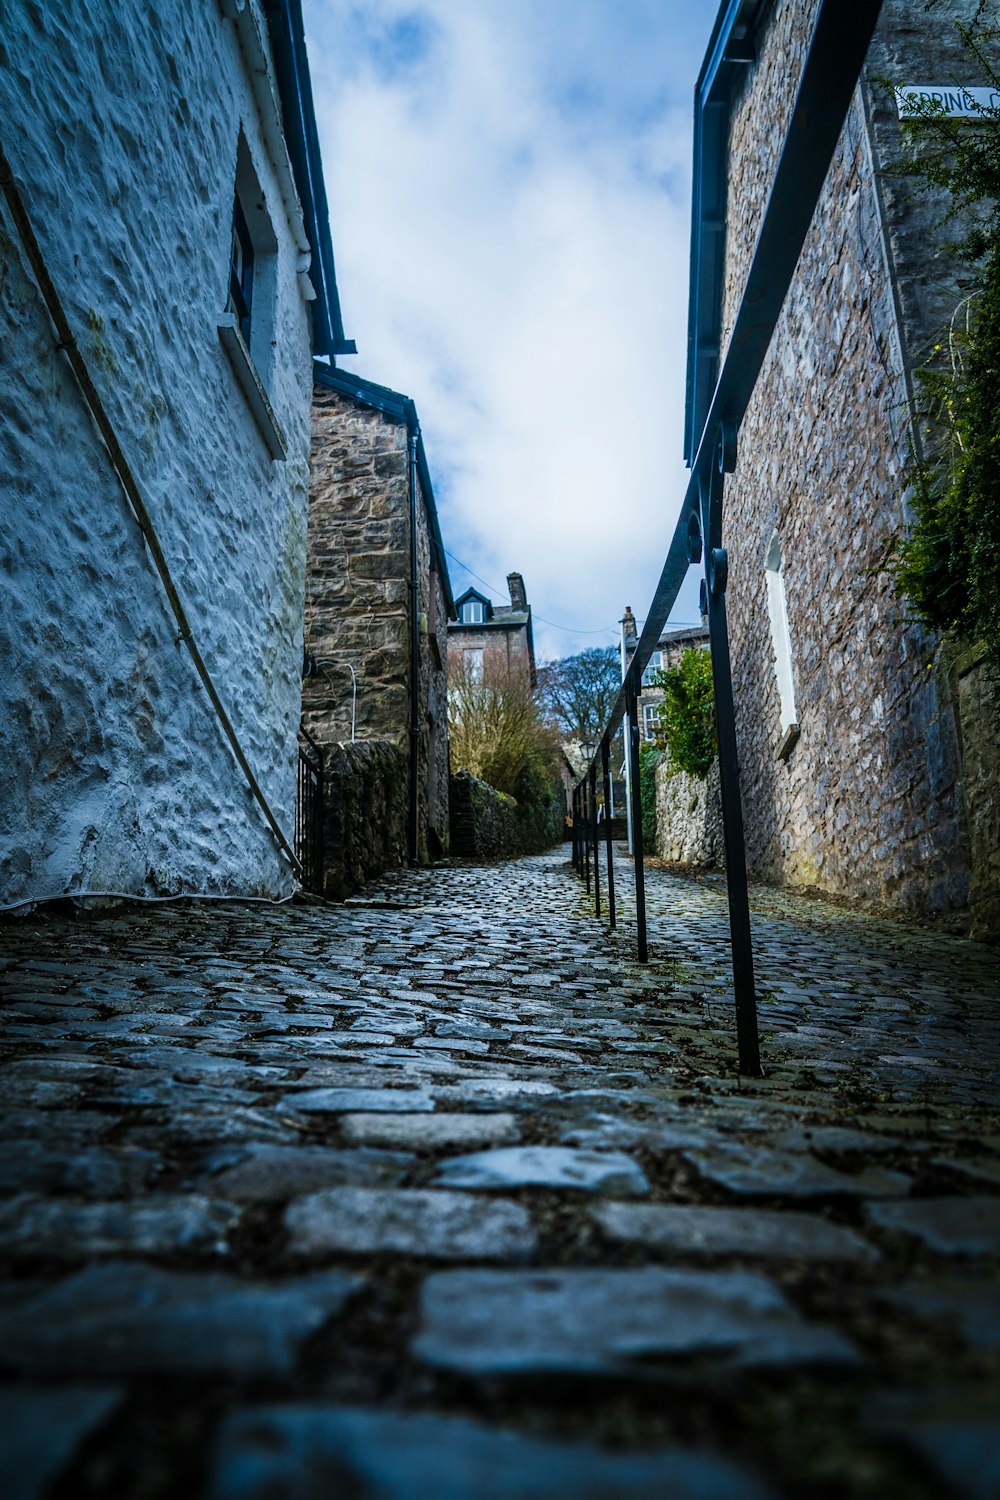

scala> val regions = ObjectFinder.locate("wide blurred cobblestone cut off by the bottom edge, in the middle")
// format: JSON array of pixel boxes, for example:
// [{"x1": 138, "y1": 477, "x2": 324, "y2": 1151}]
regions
[{"x1": 211, "y1": 1406, "x2": 766, "y2": 1500}]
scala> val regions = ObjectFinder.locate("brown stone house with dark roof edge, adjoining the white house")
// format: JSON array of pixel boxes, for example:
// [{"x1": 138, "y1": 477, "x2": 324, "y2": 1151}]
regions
[{"x1": 303, "y1": 363, "x2": 454, "y2": 876}]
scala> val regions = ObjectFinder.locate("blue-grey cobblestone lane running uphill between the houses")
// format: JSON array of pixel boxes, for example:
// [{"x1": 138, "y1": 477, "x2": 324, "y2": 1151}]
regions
[{"x1": 0, "y1": 851, "x2": 1000, "y2": 1500}]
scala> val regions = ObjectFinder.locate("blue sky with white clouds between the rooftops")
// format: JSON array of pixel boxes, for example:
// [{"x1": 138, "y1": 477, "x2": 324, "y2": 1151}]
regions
[{"x1": 304, "y1": 0, "x2": 717, "y2": 660}]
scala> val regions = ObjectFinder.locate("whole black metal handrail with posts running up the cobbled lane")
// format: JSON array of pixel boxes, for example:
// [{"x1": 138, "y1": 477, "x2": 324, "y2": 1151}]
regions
[{"x1": 573, "y1": 0, "x2": 882, "y2": 1077}]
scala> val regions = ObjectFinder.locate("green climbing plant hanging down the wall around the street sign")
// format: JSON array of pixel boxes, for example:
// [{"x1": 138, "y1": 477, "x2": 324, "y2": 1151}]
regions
[{"x1": 889, "y1": 27, "x2": 1000, "y2": 671}]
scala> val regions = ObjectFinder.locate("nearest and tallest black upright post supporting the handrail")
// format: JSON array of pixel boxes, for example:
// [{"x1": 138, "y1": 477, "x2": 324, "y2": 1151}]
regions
[{"x1": 700, "y1": 425, "x2": 763, "y2": 1079}]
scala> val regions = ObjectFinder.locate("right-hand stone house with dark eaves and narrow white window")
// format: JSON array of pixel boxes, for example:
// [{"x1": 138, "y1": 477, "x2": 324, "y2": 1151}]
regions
[{"x1": 687, "y1": 0, "x2": 1000, "y2": 932}]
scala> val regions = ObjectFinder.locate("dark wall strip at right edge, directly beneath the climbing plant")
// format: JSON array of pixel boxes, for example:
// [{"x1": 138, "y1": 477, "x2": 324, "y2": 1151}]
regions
[{"x1": 955, "y1": 650, "x2": 1000, "y2": 942}]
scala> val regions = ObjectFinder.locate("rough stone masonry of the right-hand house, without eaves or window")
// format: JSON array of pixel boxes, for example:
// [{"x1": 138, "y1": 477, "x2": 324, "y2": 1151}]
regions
[{"x1": 716, "y1": 0, "x2": 969, "y2": 911}]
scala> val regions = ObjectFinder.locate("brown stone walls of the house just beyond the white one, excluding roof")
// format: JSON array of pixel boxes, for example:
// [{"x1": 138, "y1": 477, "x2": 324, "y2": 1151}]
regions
[{"x1": 303, "y1": 384, "x2": 448, "y2": 861}]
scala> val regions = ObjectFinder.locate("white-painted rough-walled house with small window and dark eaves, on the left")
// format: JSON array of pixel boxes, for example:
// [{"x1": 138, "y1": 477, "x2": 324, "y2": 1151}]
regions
[{"x1": 0, "y1": 0, "x2": 352, "y2": 905}]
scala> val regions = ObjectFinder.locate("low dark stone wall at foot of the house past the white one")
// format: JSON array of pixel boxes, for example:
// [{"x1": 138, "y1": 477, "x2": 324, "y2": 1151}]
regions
[{"x1": 322, "y1": 740, "x2": 408, "y2": 902}]
